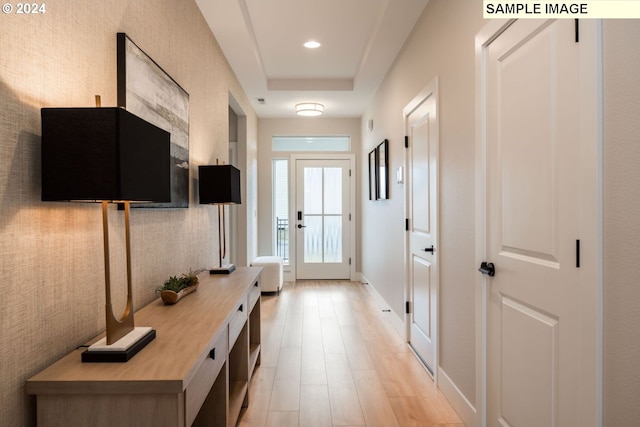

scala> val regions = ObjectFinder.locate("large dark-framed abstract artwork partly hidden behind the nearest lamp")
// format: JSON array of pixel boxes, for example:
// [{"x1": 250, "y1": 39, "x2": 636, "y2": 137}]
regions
[{"x1": 117, "y1": 33, "x2": 189, "y2": 208}]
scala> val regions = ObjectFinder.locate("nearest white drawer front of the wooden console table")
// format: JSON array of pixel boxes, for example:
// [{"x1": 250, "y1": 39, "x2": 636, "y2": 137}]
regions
[{"x1": 185, "y1": 329, "x2": 228, "y2": 426}]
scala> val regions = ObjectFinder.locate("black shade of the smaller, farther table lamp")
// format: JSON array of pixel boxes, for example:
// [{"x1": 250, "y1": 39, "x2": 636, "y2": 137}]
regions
[{"x1": 198, "y1": 165, "x2": 241, "y2": 205}]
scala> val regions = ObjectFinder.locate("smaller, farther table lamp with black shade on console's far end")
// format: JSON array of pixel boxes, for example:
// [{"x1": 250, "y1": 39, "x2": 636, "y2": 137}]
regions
[{"x1": 198, "y1": 165, "x2": 241, "y2": 274}]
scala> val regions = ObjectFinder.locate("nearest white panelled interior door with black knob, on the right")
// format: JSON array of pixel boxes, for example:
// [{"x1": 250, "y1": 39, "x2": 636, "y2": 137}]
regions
[{"x1": 483, "y1": 20, "x2": 596, "y2": 427}]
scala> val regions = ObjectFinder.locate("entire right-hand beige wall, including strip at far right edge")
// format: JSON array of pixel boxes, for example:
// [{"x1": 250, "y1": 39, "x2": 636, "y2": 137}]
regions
[{"x1": 360, "y1": 5, "x2": 640, "y2": 426}]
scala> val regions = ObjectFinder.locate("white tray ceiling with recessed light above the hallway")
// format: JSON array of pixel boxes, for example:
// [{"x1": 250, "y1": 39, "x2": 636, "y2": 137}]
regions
[{"x1": 196, "y1": 0, "x2": 429, "y2": 118}]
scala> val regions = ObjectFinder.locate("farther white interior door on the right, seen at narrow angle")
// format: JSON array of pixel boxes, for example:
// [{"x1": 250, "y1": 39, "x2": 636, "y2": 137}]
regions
[{"x1": 405, "y1": 80, "x2": 438, "y2": 374}]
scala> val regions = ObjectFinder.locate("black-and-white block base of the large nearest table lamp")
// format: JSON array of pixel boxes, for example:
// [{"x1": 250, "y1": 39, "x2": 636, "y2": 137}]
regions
[{"x1": 82, "y1": 327, "x2": 156, "y2": 363}]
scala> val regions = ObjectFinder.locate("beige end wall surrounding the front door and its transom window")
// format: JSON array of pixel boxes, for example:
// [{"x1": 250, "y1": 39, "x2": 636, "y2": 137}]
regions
[{"x1": 258, "y1": 117, "x2": 361, "y2": 280}]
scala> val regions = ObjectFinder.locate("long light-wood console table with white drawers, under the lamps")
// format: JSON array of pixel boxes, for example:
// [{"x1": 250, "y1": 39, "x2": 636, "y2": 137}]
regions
[{"x1": 26, "y1": 267, "x2": 262, "y2": 427}]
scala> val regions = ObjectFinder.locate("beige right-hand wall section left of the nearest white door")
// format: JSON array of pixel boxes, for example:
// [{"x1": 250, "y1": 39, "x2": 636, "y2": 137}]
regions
[{"x1": 360, "y1": 0, "x2": 484, "y2": 414}]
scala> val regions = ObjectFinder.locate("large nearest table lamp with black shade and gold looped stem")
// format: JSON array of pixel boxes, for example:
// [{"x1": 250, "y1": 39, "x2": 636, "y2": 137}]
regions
[{"x1": 41, "y1": 108, "x2": 171, "y2": 362}]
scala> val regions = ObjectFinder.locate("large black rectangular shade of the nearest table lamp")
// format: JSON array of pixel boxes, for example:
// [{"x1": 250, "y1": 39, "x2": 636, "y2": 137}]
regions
[{"x1": 41, "y1": 108, "x2": 171, "y2": 202}]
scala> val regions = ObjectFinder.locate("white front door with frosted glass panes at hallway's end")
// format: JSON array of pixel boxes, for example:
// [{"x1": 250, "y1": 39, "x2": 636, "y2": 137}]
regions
[{"x1": 291, "y1": 159, "x2": 350, "y2": 280}]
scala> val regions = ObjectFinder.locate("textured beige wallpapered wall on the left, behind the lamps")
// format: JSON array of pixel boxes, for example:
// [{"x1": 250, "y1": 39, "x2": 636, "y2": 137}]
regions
[{"x1": 0, "y1": 0, "x2": 257, "y2": 426}]
